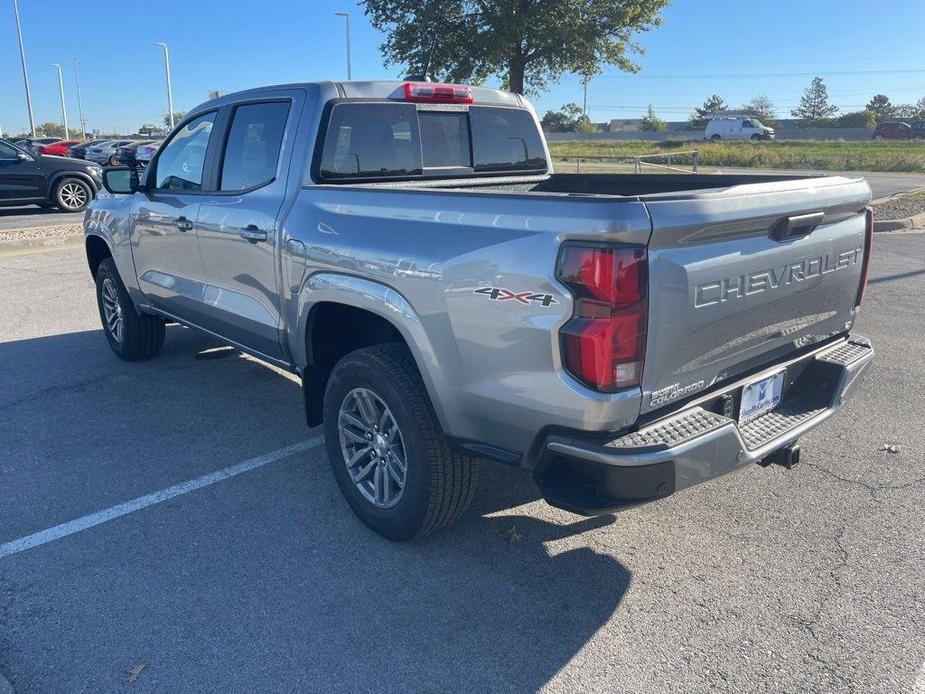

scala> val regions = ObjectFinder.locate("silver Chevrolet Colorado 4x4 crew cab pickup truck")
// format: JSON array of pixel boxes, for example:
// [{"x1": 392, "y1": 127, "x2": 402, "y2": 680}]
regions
[{"x1": 85, "y1": 81, "x2": 873, "y2": 540}]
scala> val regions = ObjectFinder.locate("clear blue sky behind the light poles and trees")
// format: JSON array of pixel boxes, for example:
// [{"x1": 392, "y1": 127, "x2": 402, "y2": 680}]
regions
[{"x1": 0, "y1": 0, "x2": 925, "y2": 137}]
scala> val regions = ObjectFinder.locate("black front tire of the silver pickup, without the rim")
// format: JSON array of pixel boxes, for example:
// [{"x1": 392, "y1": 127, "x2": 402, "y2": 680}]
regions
[{"x1": 96, "y1": 258, "x2": 164, "y2": 361}]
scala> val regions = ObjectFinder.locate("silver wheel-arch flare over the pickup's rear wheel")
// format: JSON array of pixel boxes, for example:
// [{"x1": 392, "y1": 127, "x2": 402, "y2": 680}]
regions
[{"x1": 288, "y1": 272, "x2": 447, "y2": 430}]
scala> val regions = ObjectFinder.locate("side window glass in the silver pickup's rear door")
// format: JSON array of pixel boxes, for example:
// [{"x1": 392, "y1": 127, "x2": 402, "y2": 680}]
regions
[{"x1": 219, "y1": 101, "x2": 289, "y2": 191}]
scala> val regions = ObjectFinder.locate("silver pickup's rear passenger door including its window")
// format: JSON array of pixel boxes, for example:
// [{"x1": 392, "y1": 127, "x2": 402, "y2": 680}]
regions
[{"x1": 198, "y1": 90, "x2": 303, "y2": 359}]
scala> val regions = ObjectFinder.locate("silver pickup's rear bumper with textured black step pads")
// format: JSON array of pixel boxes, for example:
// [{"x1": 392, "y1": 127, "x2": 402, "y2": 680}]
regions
[{"x1": 534, "y1": 336, "x2": 874, "y2": 515}]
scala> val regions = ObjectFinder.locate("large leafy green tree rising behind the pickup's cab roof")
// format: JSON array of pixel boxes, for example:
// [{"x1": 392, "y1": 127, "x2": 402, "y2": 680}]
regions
[{"x1": 363, "y1": 0, "x2": 669, "y2": 94}]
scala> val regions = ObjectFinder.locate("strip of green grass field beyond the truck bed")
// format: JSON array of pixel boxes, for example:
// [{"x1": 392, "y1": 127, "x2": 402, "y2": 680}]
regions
[{"x1": 549, "y1": 140, "x2": 925, "y2": 173}]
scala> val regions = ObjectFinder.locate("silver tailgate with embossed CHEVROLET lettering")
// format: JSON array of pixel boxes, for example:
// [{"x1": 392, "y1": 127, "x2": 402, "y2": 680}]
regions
[{"x1": 642, "y1": 177, "x2": 870, "y2": 412}]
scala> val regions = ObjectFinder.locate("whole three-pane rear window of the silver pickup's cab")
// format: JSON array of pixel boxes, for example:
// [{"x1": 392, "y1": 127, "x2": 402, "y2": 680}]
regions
[{"x1": 313, "y1": 101, "x2": 548, "y2": 183}]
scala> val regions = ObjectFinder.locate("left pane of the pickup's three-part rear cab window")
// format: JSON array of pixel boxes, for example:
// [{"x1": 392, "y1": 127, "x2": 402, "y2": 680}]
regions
[{"x1": 320, "y1": 103, "x2": 423, "y2": 180}]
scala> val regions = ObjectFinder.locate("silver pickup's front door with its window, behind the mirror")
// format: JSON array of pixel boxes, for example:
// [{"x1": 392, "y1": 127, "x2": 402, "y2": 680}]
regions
[{"x1": 133, "y1": 111, "x2": 217, "y2": 325}]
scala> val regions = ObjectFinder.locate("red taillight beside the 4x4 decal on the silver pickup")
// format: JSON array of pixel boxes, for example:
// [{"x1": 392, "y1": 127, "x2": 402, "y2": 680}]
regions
[{"x1": 556, "y1": 244, "x2": 649, "y2": 392}]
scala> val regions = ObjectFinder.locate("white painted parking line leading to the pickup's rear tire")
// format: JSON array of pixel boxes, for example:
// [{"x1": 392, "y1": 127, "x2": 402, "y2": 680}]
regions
[{"x1": 0, "y1": 436, "x2": 324, "y2": 559}]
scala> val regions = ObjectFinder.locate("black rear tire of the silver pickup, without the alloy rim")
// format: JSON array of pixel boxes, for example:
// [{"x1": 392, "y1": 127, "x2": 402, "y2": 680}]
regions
[{"x1": 324, "y1": 343, "x2": 477, "y2": 541}]
